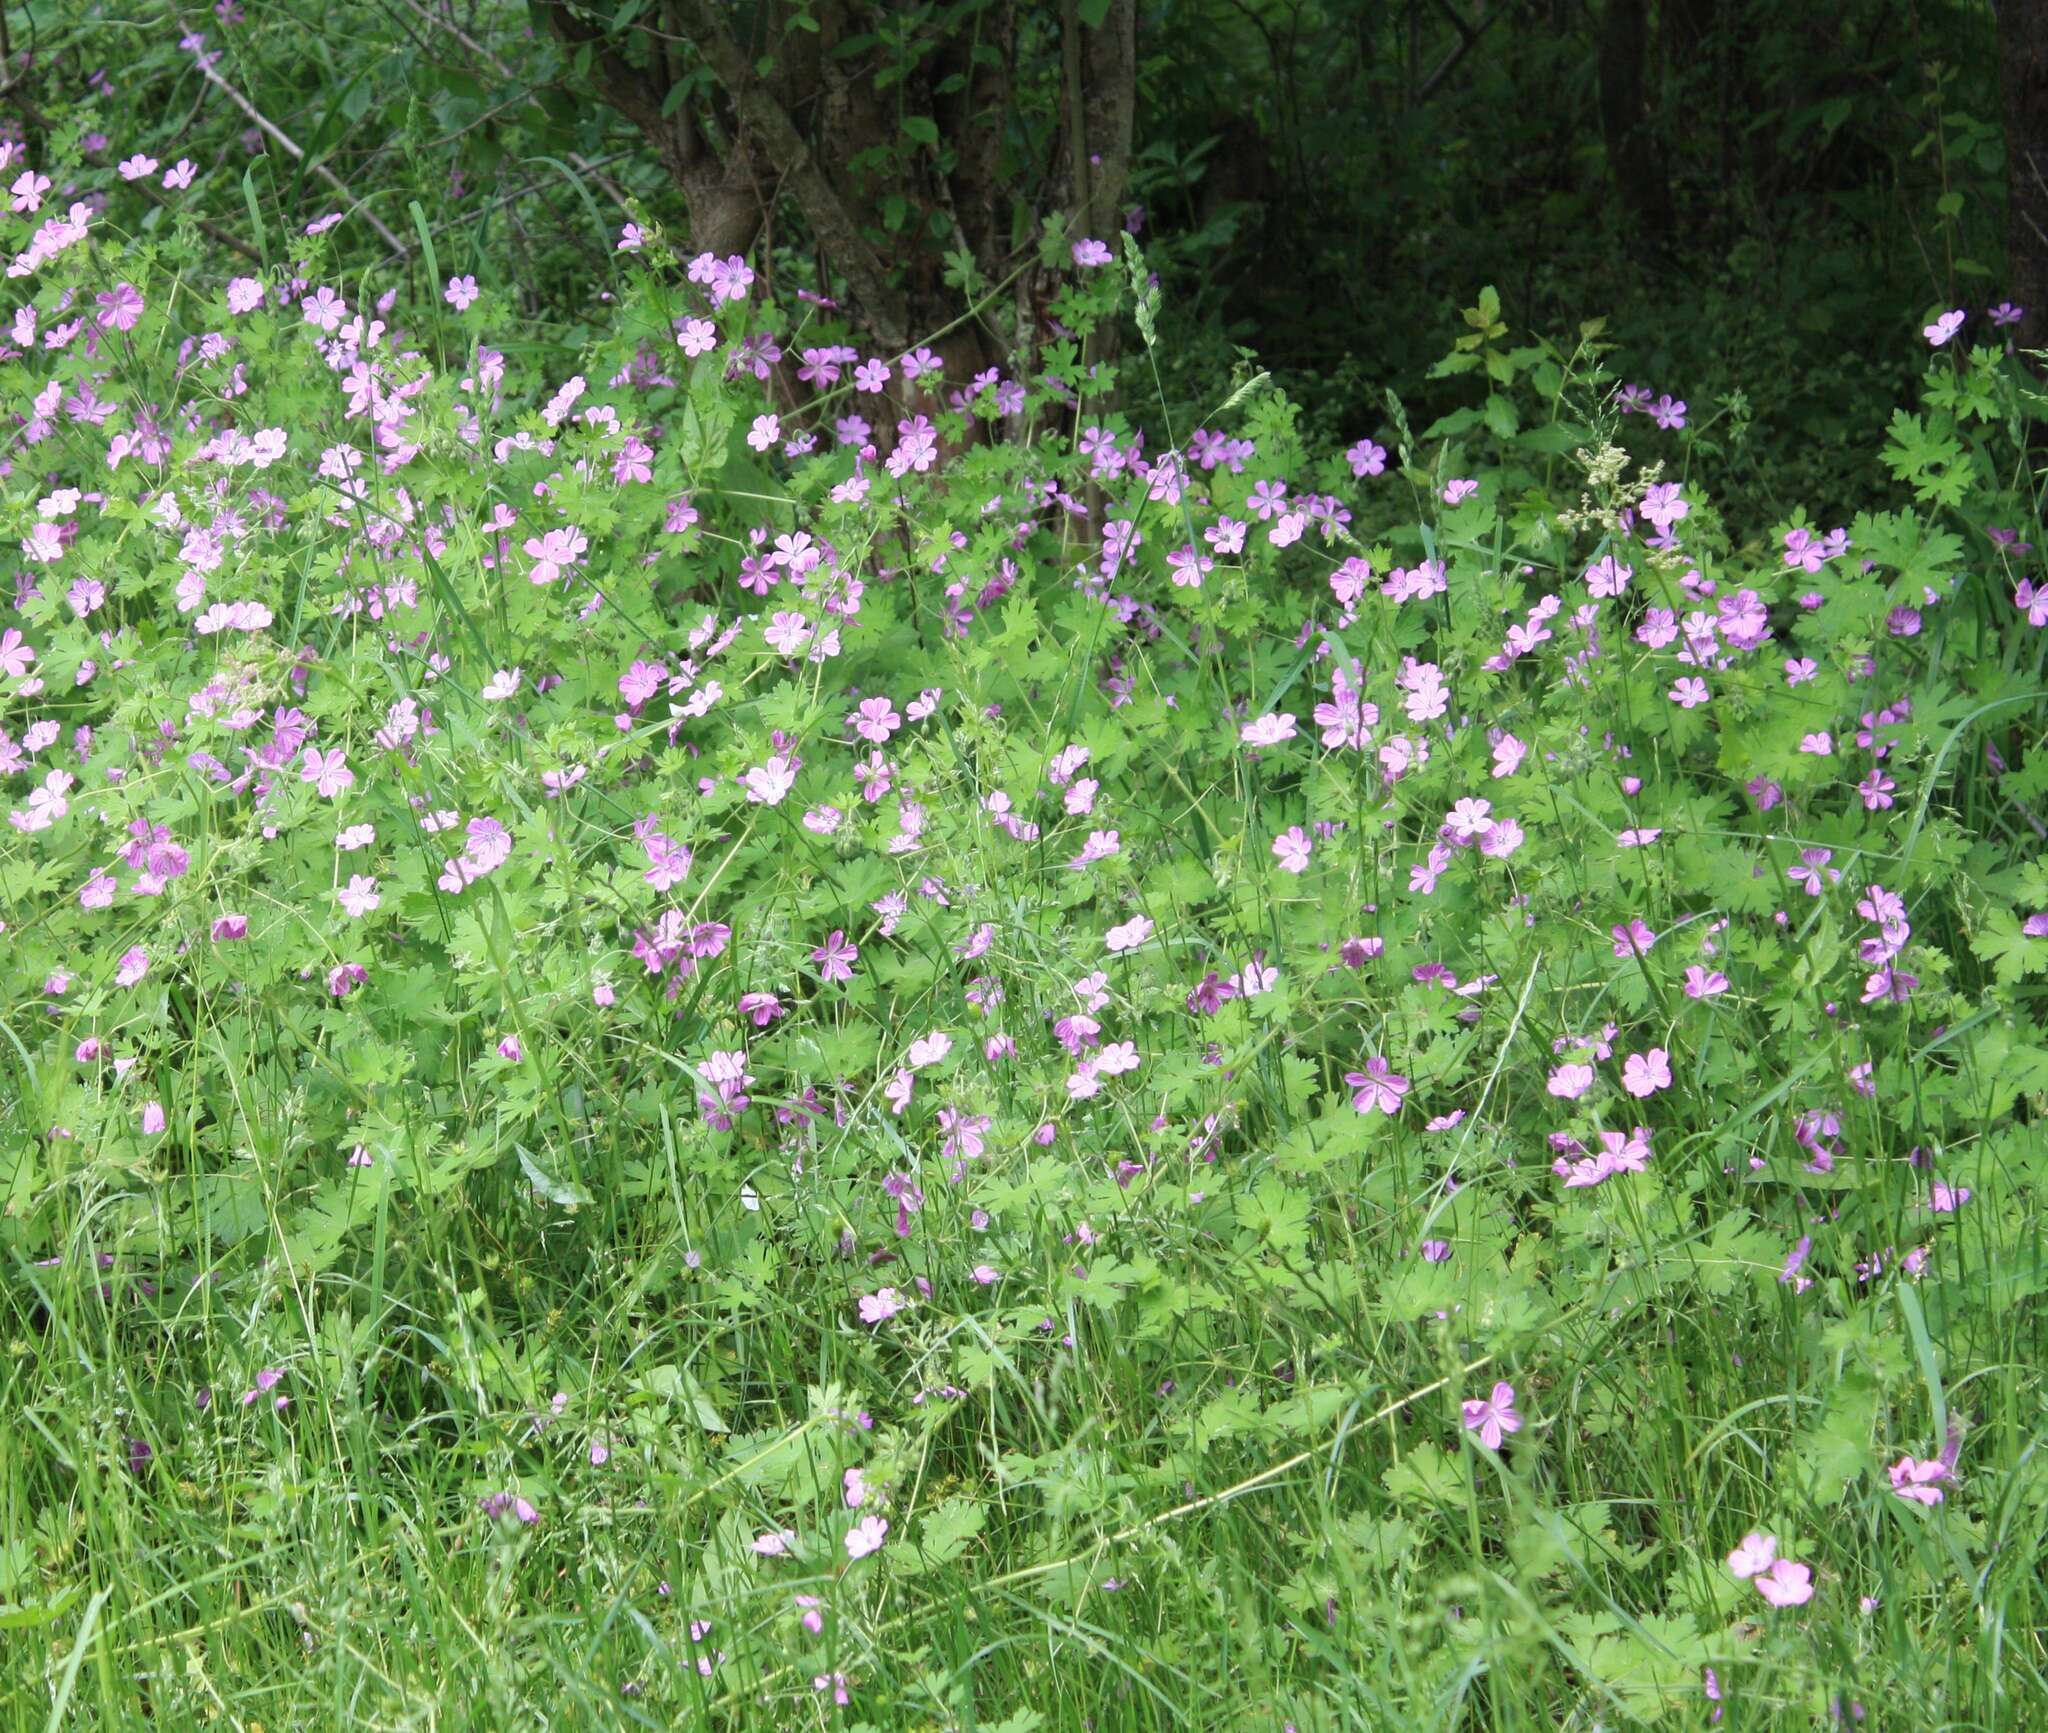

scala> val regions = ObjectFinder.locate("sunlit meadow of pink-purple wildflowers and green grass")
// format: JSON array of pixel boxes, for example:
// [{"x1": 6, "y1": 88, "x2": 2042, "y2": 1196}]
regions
[{"x1": 0, "y1": 6, "x2": 2048, "y2": 1733}]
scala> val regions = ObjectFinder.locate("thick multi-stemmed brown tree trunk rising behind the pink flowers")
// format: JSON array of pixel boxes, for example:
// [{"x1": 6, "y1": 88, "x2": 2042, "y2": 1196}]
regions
[{"x1": 535, "y1": 0, "x2": 1137, "y2": 376}]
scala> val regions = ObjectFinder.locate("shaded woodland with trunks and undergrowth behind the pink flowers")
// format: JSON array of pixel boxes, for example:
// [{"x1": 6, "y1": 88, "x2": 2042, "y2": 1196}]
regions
[{"x1": 0, "y1": 0, "x2": 2048, "y2": 514}]
